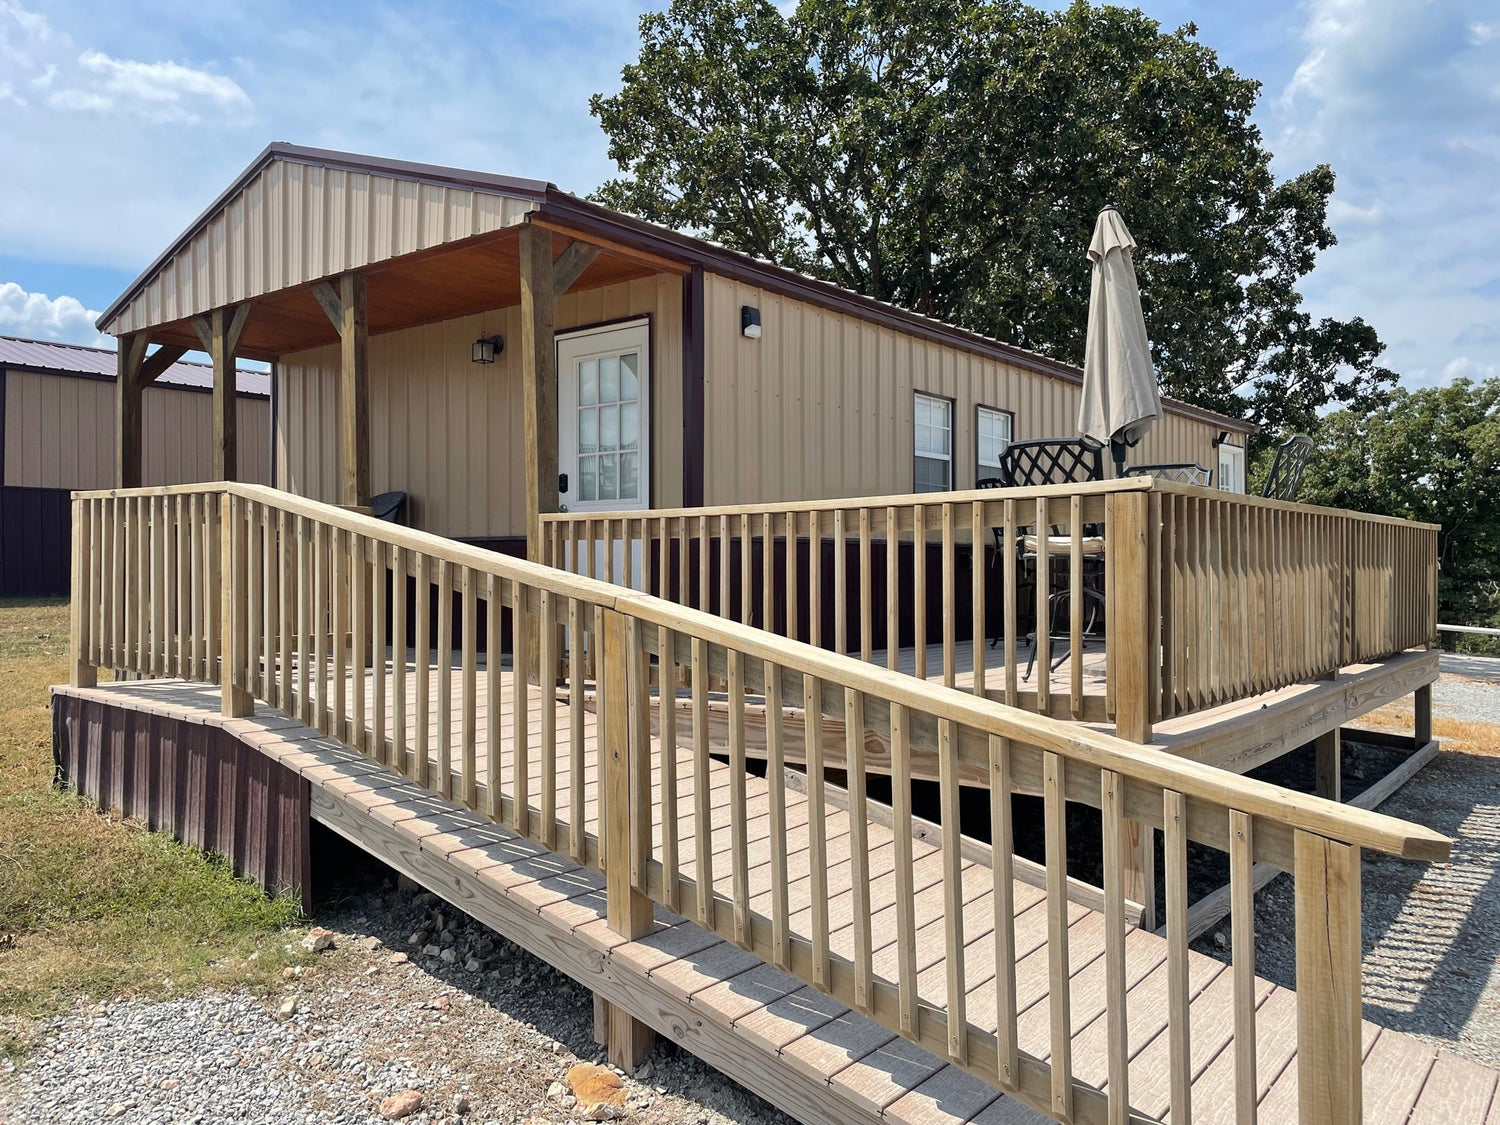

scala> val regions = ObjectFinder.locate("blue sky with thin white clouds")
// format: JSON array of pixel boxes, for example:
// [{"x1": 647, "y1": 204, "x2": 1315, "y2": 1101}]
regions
[{"x1": 0, "y1": 0, "x2": 1500, "y2": 389}]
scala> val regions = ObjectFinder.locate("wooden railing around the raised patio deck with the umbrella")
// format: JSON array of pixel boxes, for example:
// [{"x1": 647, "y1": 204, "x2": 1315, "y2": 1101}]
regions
[{"x1": 542, "y1": 479, "x2": 1437, "y2": 741}]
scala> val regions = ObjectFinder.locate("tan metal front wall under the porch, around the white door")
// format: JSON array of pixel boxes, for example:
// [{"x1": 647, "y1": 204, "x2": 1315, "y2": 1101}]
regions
[{"x1": 276, "y1": 275, "x2": 683, "y2": 537}]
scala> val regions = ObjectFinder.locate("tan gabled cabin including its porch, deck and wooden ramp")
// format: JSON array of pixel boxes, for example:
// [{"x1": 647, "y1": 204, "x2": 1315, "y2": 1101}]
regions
[{"x1": 54, "y1": 144, "x2": 1497, "y2": 1125}]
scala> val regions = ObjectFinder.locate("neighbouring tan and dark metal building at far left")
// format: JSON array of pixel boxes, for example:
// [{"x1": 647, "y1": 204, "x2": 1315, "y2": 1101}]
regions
[{"x1": 0, "y1": 336, "x2": 272, "y2": 597}]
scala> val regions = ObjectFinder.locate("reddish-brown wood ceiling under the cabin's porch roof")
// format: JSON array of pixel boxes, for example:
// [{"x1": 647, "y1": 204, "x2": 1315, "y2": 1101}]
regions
[{"x1": 141, "y1": 227, "x2": 660, "y2": 360}]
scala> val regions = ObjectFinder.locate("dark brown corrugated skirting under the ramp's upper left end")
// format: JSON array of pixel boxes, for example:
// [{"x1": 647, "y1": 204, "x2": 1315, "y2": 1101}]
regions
[{"x1": 53, "y1": 695, "x2": 312, "y2": 911}]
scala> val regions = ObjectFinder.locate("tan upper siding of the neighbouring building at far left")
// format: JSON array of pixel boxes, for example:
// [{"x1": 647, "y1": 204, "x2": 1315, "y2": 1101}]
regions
[{"x1": 5, "y1": 371, "x2": 270, "y2": 489}]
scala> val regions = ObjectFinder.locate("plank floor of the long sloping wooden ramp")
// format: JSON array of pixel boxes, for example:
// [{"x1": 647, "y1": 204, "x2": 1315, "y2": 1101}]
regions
[{"x1": 57, "y1": 669, "x2": 1500, "y2": 1125}]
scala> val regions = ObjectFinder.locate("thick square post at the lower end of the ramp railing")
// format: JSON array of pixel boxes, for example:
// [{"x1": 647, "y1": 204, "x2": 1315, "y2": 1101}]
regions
[{"x1": 1293, "y1": 831, "x2": 1364, "y2": 1125}]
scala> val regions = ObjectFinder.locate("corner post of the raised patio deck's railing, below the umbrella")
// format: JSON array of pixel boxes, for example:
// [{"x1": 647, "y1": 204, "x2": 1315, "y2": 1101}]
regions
[{"x1": 1107, "y1": 492, "x2": 1157, "y2": 930}]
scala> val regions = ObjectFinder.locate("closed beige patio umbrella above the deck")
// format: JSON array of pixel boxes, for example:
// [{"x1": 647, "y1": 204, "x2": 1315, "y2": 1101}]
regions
[{"x1": 1079, "y1": 207, "x2": 1161, "y2": 476}]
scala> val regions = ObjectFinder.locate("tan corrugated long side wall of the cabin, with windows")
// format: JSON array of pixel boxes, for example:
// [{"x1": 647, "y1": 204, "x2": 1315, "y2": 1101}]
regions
[{"x1": 704, "y1": 275, "x2": 1242, "y2": 504}]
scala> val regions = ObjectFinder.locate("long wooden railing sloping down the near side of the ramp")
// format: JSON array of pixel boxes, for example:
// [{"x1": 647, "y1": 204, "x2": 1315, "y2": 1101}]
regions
[{"x1": 72, "y1": 485, "x2": 1449, "y2": 1124}]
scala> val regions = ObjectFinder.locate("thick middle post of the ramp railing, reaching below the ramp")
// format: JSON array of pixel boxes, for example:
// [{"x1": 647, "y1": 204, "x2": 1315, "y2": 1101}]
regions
[{"x1": 594, "y1": 609, "x2": 654, "y2": 1071}]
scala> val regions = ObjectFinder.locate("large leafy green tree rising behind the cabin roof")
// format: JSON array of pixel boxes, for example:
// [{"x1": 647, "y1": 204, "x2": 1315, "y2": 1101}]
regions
[{"x1": 590, "y1": 0, "x2": 1395, "y2": 434}]
